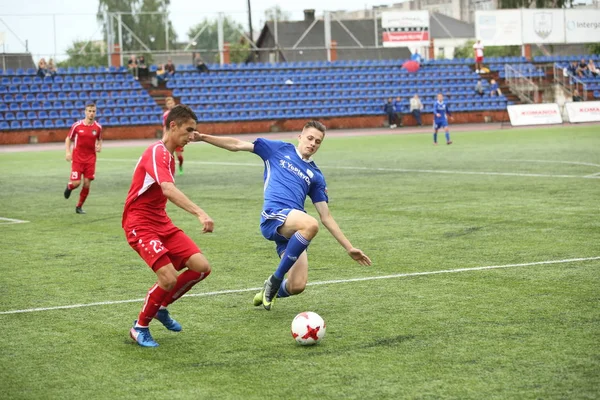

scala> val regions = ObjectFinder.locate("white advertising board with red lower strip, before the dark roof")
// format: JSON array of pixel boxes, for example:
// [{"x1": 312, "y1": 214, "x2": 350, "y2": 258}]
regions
[{"x1": 381, "y1": 11, "x2": 430, "y2": 47}]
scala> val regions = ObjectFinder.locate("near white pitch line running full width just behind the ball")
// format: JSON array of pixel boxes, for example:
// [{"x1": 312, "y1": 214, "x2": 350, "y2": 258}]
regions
[{"x1": 0, "y1": 256, "x2": 600, "y2": 315}]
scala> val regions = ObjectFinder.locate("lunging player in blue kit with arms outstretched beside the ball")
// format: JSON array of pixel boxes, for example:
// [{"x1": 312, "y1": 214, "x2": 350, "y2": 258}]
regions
[{"x1": 196, "y1": 121, "x2": 371, "y2": 310}]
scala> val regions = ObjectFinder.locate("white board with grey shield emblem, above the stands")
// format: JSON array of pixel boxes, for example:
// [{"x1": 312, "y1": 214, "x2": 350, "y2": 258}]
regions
[{"x1": 522, "y1": 9, "x2": 565, "y2": 43}]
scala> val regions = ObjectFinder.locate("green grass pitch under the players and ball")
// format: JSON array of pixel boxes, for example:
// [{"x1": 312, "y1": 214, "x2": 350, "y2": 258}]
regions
[{"x1": 0, "y1": 126, "x2": 600, "y2": 399}]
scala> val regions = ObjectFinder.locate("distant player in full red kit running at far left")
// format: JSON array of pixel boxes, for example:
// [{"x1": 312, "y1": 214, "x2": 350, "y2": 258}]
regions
[{"x1": 64, "y1": 103, "x2": 102, "y2": 214}]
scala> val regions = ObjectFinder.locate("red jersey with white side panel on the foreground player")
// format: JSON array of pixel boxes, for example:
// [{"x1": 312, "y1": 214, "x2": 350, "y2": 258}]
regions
[{"x1": 122, "y1": 141, "x2": 175, "y2": 227}]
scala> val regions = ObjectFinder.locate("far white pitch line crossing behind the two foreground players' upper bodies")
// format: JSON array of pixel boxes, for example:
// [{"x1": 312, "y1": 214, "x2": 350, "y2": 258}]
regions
[{"x1": 101, "y1": 158, "x2": 600, "y2": 179}]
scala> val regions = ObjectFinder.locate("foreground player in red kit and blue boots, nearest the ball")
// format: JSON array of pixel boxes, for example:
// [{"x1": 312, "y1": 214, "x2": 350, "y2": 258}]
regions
[{"x1": 122, "y1": 105, "x2": 214, "y2": 347}]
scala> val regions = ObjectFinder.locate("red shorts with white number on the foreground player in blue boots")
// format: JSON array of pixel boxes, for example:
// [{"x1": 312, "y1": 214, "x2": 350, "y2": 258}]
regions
[{"x1": 124, "y1": 223, "x2": 202, "y2": 272}]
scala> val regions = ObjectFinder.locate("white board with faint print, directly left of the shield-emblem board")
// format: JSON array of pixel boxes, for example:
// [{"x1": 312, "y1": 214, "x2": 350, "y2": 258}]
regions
[{"x1": 475, "y1": 10, "x2": 523, "y2": 46}]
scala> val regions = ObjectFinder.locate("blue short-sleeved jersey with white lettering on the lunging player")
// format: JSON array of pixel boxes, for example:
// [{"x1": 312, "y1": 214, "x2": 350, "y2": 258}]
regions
[{"x1": 254, "y1": 138, "x2": 329, "y2": 211}]
